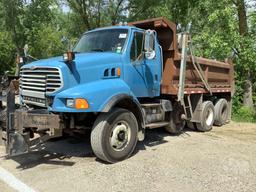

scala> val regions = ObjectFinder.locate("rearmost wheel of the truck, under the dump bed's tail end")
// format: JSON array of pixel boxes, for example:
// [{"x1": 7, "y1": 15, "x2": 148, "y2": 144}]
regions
[{"x1": 214, "y1": 99, "x2": 229, "y2": 126}]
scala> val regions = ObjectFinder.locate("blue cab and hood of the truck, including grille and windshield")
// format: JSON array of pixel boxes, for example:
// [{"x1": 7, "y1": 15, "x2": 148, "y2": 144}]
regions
[{"x1": 20, "y1": 26, "x2": 162, "y2": 113}]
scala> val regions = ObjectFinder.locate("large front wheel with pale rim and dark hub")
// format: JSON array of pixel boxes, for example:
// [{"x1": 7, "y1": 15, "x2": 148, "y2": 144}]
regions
[{"x1": 91, "y1": 108, "x2": 138, "y2": 163}]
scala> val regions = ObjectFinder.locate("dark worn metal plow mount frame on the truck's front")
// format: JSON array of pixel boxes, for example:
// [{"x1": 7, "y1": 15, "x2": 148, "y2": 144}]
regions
[{"x1": 0, "y1": 82, "x2": 62, "y2": 157}]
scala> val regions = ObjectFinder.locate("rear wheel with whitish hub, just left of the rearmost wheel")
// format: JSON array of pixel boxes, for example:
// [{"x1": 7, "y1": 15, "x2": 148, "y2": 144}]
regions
[{"x1": 196, "y1": 101, "x2": 214, "y2": 132}]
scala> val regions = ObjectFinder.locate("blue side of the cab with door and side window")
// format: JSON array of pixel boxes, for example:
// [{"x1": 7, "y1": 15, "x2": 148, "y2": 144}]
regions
[{"x1": 125, "y1": 30, "x2": 162, "y2": 97}]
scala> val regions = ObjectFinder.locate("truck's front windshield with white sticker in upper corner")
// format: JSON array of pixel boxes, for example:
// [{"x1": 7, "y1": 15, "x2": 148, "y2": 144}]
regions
[{"x1": 74, "y1": 29, "x2": 128, "y2": 53}]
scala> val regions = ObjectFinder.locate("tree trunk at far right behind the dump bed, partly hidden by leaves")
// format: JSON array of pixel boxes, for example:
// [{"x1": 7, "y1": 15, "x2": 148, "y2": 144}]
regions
[{"x1": 236, "y1": 0, "x2": 253, "y2": 108}]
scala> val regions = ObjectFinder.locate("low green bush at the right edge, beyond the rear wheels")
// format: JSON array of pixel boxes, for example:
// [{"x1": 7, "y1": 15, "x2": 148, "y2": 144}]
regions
[{"x1": 233, "y1": 107, "x2": 256, "y2": 123}]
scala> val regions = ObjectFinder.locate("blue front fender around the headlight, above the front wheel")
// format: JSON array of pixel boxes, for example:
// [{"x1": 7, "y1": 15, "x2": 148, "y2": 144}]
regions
[{"x1": 49, "y1": 79, "x2": 134, "y2": 112}]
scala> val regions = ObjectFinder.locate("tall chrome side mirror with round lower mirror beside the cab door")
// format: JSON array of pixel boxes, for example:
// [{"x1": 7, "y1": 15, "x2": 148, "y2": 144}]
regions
[{"x1": 144, "y1": 30, "x2": 156, "y2": 59}]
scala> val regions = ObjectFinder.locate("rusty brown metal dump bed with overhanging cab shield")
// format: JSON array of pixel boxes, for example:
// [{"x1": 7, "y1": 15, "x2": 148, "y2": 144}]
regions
[{"x1": 129, "y1": 17, "x2": 234, "y2": 95}]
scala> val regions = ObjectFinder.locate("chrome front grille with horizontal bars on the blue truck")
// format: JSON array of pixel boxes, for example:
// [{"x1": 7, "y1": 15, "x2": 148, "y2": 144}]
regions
[{"x1": 20, "y1": 67, "x2": 63, "y2": 107}]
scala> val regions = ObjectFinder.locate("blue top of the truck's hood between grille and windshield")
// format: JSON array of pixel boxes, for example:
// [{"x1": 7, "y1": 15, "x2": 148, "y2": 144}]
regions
[{"x1": 22, "y1": 52, "x2": 121, "y2": 91}]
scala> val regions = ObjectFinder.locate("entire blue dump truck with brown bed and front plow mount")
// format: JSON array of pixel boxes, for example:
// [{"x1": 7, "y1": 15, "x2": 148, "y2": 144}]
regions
[{"x1": 1, "y1": 17, "x2": 234, "y2": 163}]
